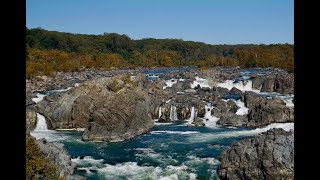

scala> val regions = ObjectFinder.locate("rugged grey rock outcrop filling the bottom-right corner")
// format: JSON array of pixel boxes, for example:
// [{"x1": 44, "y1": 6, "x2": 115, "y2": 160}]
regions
[{"x1": 218, "y1": 129, "x2": 294, "y2": 180}]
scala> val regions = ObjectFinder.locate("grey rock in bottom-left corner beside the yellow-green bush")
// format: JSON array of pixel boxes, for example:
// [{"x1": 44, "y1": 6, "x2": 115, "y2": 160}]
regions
[{"x1": 37, "y1": 139, "x2": 86, "y2": 180}]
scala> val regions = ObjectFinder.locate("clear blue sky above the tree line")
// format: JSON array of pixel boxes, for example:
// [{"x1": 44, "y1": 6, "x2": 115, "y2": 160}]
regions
[{"x1": 26, "y1": 0, "x2": 294, "y2": 44}]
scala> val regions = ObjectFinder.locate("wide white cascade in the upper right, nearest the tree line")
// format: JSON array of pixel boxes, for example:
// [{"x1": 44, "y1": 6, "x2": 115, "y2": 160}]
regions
[{"x1": 217, "y1": 80, "x2": 260, "y2": 93}]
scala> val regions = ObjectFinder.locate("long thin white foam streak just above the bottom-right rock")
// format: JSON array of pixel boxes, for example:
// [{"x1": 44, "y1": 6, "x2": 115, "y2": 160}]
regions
[{"x1": 187, "y1": 123, "x2": 294, "y2": 142}]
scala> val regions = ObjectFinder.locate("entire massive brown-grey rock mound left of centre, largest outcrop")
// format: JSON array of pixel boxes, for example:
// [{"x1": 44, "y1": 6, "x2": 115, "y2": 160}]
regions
[{"x1": 36, "y1": 76, "x2": 154, "y2": 141}]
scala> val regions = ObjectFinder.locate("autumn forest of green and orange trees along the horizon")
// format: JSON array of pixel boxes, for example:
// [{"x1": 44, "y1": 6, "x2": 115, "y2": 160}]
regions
[{"x1": 26, "y1": 28, "x2": 294, "y2": 79}]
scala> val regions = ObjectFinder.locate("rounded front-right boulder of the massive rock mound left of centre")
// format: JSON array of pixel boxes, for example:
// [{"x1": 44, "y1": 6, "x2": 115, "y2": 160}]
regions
[{"x1": 82, "y1": 89, "x2": 154, "y2": 142}]
